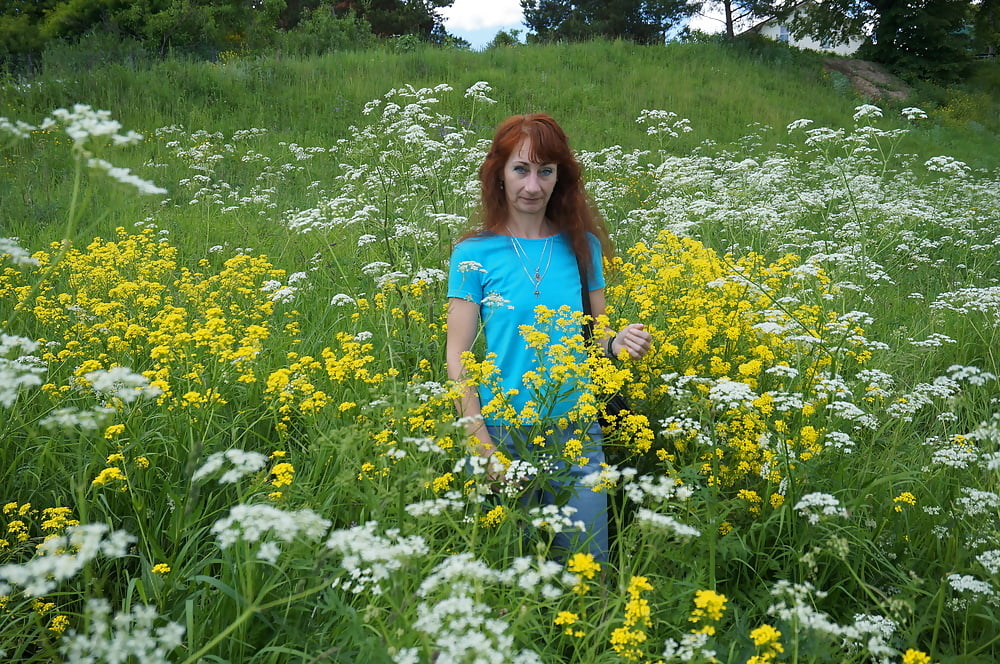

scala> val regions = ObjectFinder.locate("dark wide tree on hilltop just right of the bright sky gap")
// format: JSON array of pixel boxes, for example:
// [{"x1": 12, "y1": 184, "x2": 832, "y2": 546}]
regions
[{"x1": 521, "y1": 0, "x2": 691, "y2": 44}]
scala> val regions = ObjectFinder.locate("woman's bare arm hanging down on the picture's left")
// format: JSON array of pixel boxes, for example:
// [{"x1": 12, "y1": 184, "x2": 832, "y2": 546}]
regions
[{"x1": 445, "y1": 297, "x2": 496, "y2": 457}]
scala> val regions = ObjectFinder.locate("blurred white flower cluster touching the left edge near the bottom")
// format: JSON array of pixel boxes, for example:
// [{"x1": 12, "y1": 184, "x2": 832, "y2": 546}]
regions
[{"x1": 0, "y1": 523, "x2": 136, "y2": 597}]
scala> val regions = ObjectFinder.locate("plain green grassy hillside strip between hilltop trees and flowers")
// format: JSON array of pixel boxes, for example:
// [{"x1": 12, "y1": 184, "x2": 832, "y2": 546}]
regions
[{"x1": 0, "y1": 42, "x2": 1000, "y2": 163}]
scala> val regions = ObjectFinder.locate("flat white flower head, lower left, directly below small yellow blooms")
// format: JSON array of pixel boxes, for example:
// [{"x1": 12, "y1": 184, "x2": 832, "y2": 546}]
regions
[{"x1": 212, "y1": 504, "x2": 330, "y2": 563}]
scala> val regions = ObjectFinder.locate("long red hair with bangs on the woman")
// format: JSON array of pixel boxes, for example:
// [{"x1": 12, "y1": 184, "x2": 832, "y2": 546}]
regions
[{"x1": 469, "y1": 113, "x2": 613, "y2": 278}]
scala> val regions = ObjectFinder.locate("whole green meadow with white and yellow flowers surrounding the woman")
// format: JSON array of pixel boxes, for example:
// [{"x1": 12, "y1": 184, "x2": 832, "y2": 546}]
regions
[{"x1": 0, "y1": 43, "x2": 1000, "y2": 664}]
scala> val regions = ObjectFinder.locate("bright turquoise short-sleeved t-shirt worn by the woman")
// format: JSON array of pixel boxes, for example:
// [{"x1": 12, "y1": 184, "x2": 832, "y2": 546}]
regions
[{"x1": 448, "y1": 228, "x2": 604, "y2": 425}]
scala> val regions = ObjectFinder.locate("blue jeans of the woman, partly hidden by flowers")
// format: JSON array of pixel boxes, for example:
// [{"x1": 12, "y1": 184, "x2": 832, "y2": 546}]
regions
[{"x1": 486, "y1": 422, "x2": 608, "y2": 562}]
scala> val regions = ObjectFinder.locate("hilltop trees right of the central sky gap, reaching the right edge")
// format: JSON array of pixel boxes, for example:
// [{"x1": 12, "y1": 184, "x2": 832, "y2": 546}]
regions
[{"x1": 521, "y1": 0, "x2": 1000, "y2": 80}]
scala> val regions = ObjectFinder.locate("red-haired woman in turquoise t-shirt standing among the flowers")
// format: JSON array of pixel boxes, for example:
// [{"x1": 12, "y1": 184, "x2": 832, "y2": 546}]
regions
[{"x1": 446, "y1": 114, "x2": 650, "y2": 560}]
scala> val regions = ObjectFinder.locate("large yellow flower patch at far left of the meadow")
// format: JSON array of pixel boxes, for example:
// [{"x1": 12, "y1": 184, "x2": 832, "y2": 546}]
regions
[{"x1": 0, "y1": 228, "x2": 284, "y2": 408}]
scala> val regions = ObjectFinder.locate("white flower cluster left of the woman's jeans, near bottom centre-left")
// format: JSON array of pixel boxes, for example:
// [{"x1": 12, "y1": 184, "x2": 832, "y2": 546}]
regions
[{"x1": 326, "y1": 521, "x2": 430, "y2": 595}]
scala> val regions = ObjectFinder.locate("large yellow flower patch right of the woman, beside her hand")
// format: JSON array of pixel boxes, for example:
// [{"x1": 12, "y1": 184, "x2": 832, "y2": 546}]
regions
[{"x1": 607, "y1": 232, "x2": 871, "y2": 487}]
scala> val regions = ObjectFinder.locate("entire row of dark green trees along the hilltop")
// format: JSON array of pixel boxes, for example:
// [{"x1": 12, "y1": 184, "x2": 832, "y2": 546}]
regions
[{"x1": 0, "y1": 0, "x2": 1000, "y2": 80}]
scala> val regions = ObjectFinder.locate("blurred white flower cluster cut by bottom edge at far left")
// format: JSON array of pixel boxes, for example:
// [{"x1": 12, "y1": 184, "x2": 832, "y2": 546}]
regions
[{"x1": 59, "y1": 599, "x2": 185, "y2": 664}]
